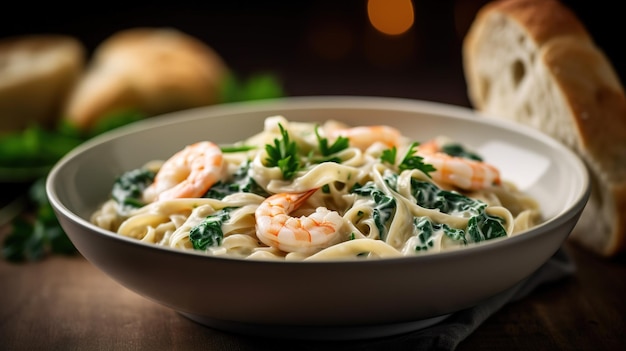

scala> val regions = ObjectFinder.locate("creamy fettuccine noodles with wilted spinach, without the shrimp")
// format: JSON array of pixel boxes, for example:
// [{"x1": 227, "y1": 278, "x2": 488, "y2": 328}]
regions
[{"x1": 91, "y1": 116, "x2": 540, "y2": 260}]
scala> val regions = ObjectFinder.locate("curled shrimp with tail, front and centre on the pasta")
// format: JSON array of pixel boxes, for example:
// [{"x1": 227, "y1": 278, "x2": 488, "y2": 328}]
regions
[{"x1": 255, "y1": 189, "x2": 344, "y2": 254}]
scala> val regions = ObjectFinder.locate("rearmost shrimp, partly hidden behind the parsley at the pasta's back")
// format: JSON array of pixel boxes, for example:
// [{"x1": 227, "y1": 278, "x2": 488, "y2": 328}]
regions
[{"x1": 326, "y1": 125, "x2": 402, "y2": 150}]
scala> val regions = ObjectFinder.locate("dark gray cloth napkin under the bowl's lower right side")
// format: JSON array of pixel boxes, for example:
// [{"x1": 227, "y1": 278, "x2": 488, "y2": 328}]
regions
[{"x1": 246, "y1": 248, "x2": 575, "y2": 351}]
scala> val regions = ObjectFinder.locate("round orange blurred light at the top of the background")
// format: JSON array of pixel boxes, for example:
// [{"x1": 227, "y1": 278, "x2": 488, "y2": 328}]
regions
[{"x1": 367, "y1": 0, "x2": 415, "y2": 35}]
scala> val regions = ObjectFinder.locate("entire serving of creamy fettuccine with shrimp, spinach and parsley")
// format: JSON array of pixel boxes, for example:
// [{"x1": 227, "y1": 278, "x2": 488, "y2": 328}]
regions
[{"x1": 91, "y1": 116, "x2": 540, "y2": 260}]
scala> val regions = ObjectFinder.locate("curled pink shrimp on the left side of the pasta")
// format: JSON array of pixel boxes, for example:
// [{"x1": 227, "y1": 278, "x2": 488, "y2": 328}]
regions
[{"x1": 143, "y1": 141, "x2": 224, "y2": 202}]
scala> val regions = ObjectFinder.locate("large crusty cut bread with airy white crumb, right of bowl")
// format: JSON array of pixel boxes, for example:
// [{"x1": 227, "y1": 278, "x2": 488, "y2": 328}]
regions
[{"x1": 463, "y1": 0, "x2": 626, "y2": 257}]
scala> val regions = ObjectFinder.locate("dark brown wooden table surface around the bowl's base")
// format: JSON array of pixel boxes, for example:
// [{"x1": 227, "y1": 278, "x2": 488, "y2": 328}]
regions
[{"x1": 0, "y1": 226, "x2": 626, "y2": 351}]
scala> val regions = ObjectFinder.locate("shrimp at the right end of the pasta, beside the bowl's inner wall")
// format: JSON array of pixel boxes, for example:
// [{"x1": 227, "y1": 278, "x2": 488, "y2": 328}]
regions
[{"x1": 417, "y1": 140, "x2": 500, "y2": 190}]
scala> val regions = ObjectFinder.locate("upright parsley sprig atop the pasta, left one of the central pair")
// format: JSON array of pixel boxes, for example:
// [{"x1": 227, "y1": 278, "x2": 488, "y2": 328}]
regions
[{"x1": 265, "y1": 123, "x2": 302, "y2": 180}]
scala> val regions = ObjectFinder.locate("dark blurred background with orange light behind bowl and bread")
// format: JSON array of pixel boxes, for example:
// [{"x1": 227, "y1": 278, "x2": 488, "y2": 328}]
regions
[{"x1": 0, "y1": 0, "x2": 626, "y2": 105}]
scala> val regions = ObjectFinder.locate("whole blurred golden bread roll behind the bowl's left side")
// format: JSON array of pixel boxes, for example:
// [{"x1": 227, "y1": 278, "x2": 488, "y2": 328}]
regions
[{"x1": 64, "y1": 27, "x2": 227, "y2": 129}]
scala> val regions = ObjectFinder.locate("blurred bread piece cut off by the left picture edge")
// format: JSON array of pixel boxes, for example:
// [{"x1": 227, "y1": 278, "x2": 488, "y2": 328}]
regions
[{"x1": 0, "y1": 34, "x2": 85, "y2": 133}]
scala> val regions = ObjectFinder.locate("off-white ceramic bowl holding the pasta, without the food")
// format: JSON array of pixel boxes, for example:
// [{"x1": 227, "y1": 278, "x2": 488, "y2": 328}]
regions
[{"x1": 47, "y1": 97, "x2": 589, "y2": 338}]
